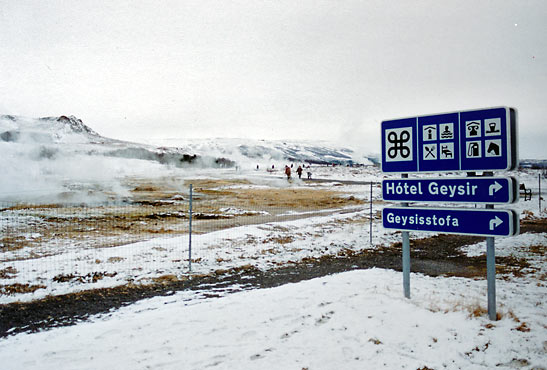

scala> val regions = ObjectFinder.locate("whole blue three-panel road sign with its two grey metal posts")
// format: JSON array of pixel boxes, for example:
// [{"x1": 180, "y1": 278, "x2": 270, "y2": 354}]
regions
[{"x1": 382, "y1": 107, "x2": 519, "y2": 320}]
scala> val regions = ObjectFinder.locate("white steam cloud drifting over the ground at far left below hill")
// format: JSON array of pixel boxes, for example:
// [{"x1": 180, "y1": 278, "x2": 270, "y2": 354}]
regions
[{"x1": 0, "y1": 143, "x2": 174, "y2": 203}]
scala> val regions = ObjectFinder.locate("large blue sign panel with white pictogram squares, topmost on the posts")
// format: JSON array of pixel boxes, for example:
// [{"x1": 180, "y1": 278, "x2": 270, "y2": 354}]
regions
[{"x1": 382, "y1": 107, "x2": 518, "y2": 173}]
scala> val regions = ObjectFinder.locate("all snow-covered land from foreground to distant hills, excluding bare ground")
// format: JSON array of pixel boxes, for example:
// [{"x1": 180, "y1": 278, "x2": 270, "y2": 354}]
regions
[{"x1": 0, "y1": 116, "x2": 547, "y2": 370}]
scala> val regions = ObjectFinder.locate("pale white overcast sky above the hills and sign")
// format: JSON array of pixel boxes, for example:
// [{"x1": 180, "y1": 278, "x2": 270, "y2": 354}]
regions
[{"x1": 0, "y1": 0, "x2": 547, "y2": 158}]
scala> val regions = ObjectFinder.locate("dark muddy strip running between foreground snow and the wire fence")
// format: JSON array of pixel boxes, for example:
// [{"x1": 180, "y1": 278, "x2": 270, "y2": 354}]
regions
[{"x1": 0, "y1": 219, "x2": 547, "y2": 337}]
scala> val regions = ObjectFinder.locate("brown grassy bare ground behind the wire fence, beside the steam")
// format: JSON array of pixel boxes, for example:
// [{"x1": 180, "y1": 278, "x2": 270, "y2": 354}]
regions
[{"x1": 0, "y1": 178, "x2": 362, "y2": 261}]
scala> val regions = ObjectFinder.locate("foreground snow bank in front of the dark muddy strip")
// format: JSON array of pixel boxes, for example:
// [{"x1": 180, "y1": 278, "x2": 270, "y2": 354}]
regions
[{"x1": 0, "y1": 269, "x2": 547, "y2": 370}]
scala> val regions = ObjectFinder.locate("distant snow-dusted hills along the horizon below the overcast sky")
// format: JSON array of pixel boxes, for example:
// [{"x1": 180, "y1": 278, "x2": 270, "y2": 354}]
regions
[{"x1": 0, "y1": 115, "x2": 371, "y2": 168}]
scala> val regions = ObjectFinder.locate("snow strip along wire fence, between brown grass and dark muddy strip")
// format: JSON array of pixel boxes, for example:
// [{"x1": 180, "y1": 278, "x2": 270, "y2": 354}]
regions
[{"x1": 0, "y1": 177, "x2": 386, "y2": 303}]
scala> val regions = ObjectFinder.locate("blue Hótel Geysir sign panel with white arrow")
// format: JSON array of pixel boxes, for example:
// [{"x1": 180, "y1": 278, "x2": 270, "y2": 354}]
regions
[{"x1": 382, "y1": 177, "x2": 518, "y2": 204}]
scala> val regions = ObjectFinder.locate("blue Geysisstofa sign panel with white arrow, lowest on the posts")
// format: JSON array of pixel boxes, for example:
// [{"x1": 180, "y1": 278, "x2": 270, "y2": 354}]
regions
[{"x1": 382, "y1": 207, "x2": 519, "y2": 236}]
